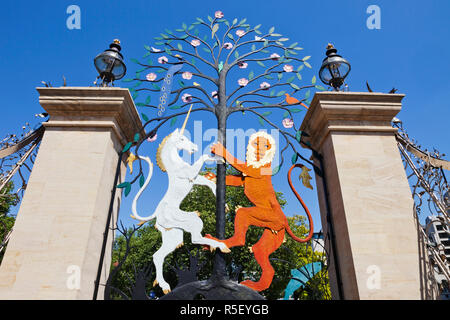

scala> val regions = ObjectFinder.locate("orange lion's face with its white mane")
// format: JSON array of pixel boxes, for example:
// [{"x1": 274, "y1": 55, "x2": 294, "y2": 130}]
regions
[{"x1": 247, "y1": 131, "x2": 276, "y2": 168}]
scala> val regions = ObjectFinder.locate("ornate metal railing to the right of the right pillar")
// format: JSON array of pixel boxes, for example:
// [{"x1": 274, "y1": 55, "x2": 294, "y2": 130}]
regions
[{"x1": 393, "y1": 118, "x2": 450, "y2": 299}]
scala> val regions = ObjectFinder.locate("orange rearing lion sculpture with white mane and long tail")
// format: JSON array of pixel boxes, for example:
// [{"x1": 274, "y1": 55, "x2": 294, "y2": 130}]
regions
[{"x1": 206, "y1": 131, "x2": 313, "y2": 291}]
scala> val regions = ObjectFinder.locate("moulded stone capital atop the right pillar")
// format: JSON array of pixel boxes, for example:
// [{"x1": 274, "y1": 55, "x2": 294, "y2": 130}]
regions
[{"x1": 300, "y1": 92, "x2": 404, "y2": 150}]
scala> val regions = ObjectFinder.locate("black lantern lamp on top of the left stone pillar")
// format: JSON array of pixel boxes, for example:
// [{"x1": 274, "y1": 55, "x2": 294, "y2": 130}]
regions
[{"x1": 94, "y1": 39, "x2": 127, "y2": 87}]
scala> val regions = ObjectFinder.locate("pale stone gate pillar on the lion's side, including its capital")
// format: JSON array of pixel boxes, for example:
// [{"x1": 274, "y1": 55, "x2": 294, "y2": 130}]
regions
[{"x1": 300, "y1": 92, "x2": 420, "y2": 299}]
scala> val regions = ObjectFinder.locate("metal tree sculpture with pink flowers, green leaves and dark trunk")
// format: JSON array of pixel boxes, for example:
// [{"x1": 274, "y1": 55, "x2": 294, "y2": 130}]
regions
[{"x1": 119, "y1": 11, "x2": 325, "y2": 298}]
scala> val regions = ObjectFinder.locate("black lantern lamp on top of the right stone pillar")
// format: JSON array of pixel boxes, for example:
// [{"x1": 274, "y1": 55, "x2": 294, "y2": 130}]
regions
[{"x1": 319, "y1": 43, "x2": 351, "y2": 91}]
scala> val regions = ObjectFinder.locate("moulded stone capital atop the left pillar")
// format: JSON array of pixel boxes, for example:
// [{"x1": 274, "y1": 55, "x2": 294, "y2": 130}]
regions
[{"x1": 37, "y1": 87, "x2": 143, "y2": 145}]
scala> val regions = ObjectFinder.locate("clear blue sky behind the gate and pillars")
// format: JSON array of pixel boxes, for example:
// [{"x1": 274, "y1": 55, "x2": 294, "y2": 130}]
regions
[{"x1": 0, "y1": 0, "x2": 450, "y2": 228}]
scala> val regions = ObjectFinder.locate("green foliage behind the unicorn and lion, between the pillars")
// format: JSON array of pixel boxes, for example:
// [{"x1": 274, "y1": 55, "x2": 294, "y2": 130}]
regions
[{"x1": 108, "y1": 168, "x2": 323, "y2": 299}]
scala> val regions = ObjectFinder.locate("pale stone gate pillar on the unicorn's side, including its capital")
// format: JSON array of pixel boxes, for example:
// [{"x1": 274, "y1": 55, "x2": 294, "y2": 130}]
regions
[{"x1": 0, "y1": 87, "x2": 142, "y2": 300}]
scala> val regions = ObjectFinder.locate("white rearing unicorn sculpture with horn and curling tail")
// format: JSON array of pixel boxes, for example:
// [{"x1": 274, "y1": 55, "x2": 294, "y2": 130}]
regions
[{"x1": 131, "y1": 105, "x2": 230, "y2": 294}]
